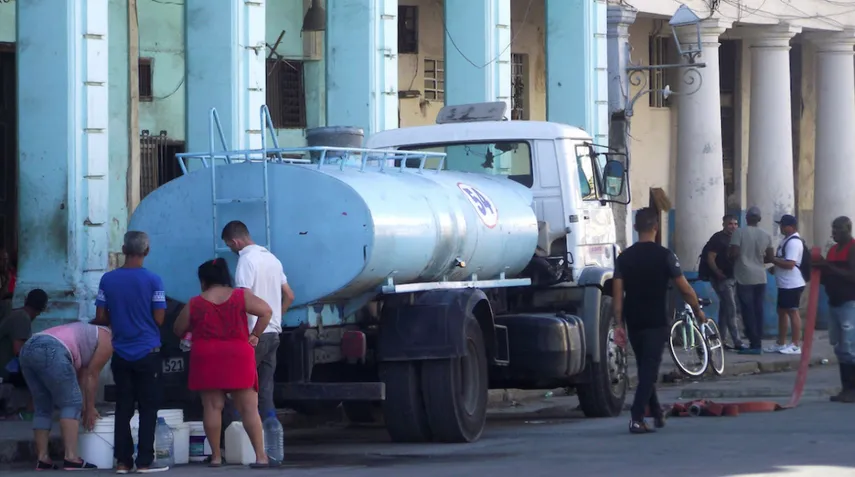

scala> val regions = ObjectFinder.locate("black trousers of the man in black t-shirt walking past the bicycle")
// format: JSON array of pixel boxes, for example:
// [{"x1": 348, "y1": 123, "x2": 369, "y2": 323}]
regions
[{"x1": 627, "y1": 327, "x2": 669, "y2": 421}]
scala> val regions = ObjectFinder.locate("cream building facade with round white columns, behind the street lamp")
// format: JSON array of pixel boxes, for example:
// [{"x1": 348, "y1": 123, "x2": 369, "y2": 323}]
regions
[{"x1": 609, "y1": 0, "x2": 855, "y2": 333}]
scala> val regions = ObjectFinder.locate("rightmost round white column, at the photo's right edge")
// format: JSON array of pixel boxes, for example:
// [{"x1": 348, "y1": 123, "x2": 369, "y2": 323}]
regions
[{"x1": 811, "y1": 30, "x2": 855, "y2": 249}]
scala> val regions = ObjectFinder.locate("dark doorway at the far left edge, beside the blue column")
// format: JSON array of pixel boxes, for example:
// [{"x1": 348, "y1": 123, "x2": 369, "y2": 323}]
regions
[{"x1": 0, "y1": 42, "x2": 18, "y2": 266}]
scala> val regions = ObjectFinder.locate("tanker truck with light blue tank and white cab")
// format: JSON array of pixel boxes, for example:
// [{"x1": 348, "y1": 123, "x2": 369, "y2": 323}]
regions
[{"x1": 107, "y1": 103, "x2": 629, "y2": 442}]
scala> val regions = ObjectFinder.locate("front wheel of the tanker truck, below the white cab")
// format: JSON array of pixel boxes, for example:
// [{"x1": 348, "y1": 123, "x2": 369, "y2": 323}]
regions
[{"x1": 576, "y1": 296, "x2": 629, "y2": 417}]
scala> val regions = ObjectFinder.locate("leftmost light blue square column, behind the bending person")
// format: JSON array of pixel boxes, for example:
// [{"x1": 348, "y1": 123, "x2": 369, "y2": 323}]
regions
[{"x1": 15, "y1": 0, "x2": 110, "y2": 327}]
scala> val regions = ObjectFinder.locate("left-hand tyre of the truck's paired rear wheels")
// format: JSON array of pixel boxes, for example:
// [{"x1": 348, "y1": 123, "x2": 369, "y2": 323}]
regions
[{"x1": 380, "y1": 361, "x2": 431, "y2": 442}]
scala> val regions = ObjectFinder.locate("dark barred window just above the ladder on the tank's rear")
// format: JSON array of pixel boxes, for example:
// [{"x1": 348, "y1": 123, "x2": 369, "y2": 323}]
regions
[{"x1": 267, "y1": 59, "x2": 306, "y2": 129}]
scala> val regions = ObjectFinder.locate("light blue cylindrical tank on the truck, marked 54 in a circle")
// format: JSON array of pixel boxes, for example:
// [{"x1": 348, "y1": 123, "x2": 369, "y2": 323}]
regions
[{"x1": 129, "y1": 154, "x2": 538, "y2": 307}]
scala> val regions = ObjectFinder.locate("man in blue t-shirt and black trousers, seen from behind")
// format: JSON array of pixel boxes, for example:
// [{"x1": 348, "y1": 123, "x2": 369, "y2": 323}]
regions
[{"x1": 93, "y1": 232, "x2": 168, "y2": 474}]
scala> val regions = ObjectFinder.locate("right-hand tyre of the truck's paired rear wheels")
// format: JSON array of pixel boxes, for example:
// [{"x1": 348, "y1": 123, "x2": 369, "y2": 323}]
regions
[{"x1": 422, "y1": 313, "x2": 488, "y2": 442}]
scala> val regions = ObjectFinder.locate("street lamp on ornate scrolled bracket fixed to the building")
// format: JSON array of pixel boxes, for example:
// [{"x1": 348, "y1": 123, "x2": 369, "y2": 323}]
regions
[{"x1": 624, "y1": 5, "x2": 707, "y2": 118}]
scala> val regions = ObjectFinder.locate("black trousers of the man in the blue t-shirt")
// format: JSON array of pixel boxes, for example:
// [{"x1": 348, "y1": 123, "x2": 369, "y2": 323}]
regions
[{"x1": 110, "y1": 353, "x2": 162, "y2": 468}]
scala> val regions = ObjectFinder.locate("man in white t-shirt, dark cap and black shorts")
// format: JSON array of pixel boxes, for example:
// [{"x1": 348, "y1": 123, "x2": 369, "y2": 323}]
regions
[{"x1": 765, "y1": 215, "x2": 805, "y2": 354}]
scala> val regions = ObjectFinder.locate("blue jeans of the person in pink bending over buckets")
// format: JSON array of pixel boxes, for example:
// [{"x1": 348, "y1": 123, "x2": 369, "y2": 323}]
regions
[{"x1": 18, "y1": 335, "x2": 83, "y2": 430}]
